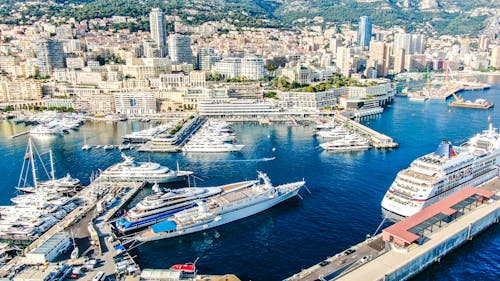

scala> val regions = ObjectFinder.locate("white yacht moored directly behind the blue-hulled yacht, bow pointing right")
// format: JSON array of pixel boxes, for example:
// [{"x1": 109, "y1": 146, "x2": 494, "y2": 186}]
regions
[{"x1": 99, "y1": 153, "x2": 193, "y2": 183}]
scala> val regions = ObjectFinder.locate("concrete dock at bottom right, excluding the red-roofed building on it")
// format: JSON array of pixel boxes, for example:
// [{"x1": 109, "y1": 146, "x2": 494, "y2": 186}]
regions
[{"x1": 285, "y1": 177, "x2": 500, "y2": 281}]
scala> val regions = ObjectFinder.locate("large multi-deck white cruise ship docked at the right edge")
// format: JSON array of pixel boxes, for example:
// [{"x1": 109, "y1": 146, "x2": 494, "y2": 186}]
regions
[{"x1": 382, "y1": 125, "x2": 500, "y2": 220}]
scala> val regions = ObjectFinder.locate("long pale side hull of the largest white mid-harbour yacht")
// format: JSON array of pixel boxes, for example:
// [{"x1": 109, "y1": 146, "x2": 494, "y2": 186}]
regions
[{"x1": 137, "y1": 188, "x2": 300, "y2": 242}]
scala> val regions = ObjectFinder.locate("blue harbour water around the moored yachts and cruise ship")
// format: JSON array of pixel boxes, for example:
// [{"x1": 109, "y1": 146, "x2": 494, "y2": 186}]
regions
[{"x1": 0, "y1": 81, "x2": 500, "y2": 280}]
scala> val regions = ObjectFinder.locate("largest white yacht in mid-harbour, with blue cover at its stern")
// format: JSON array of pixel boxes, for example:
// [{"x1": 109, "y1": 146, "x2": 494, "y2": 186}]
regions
[{"x1": 130, "y1": 172, "x2": 305, "y2": 243}]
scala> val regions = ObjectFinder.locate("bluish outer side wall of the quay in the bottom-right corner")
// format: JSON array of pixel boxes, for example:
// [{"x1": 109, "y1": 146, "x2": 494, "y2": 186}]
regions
[{"x1": 384, "y1": 208, "x2": 500, "y2": 281}]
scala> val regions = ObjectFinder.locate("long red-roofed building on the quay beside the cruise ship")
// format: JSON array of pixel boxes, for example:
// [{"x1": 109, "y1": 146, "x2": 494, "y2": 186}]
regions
[{"x1": 382, "y1": 187, "x2": 495, "y2": 247}]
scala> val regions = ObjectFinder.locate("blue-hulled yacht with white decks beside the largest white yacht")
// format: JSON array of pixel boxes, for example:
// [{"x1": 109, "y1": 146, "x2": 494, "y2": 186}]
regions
[{"x1": 116, "y1": 180, "x2": 257, "y2": 233}]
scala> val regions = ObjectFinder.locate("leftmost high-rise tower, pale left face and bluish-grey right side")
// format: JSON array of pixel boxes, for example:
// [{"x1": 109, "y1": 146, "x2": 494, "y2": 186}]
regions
[{"x1": 33, "y1": 39, "x2": 65, "y2": 76}]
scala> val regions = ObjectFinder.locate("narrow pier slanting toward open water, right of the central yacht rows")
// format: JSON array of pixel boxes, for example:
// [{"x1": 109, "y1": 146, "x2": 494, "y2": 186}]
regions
[{"x1": 333, "y1": 115, "x2": 399, "y2": 148}]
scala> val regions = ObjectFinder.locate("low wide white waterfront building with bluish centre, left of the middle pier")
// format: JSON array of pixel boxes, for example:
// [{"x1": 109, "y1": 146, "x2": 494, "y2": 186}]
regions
[{"x1": 114, "y1": 92, "x2": 156, "y2": 115}]
